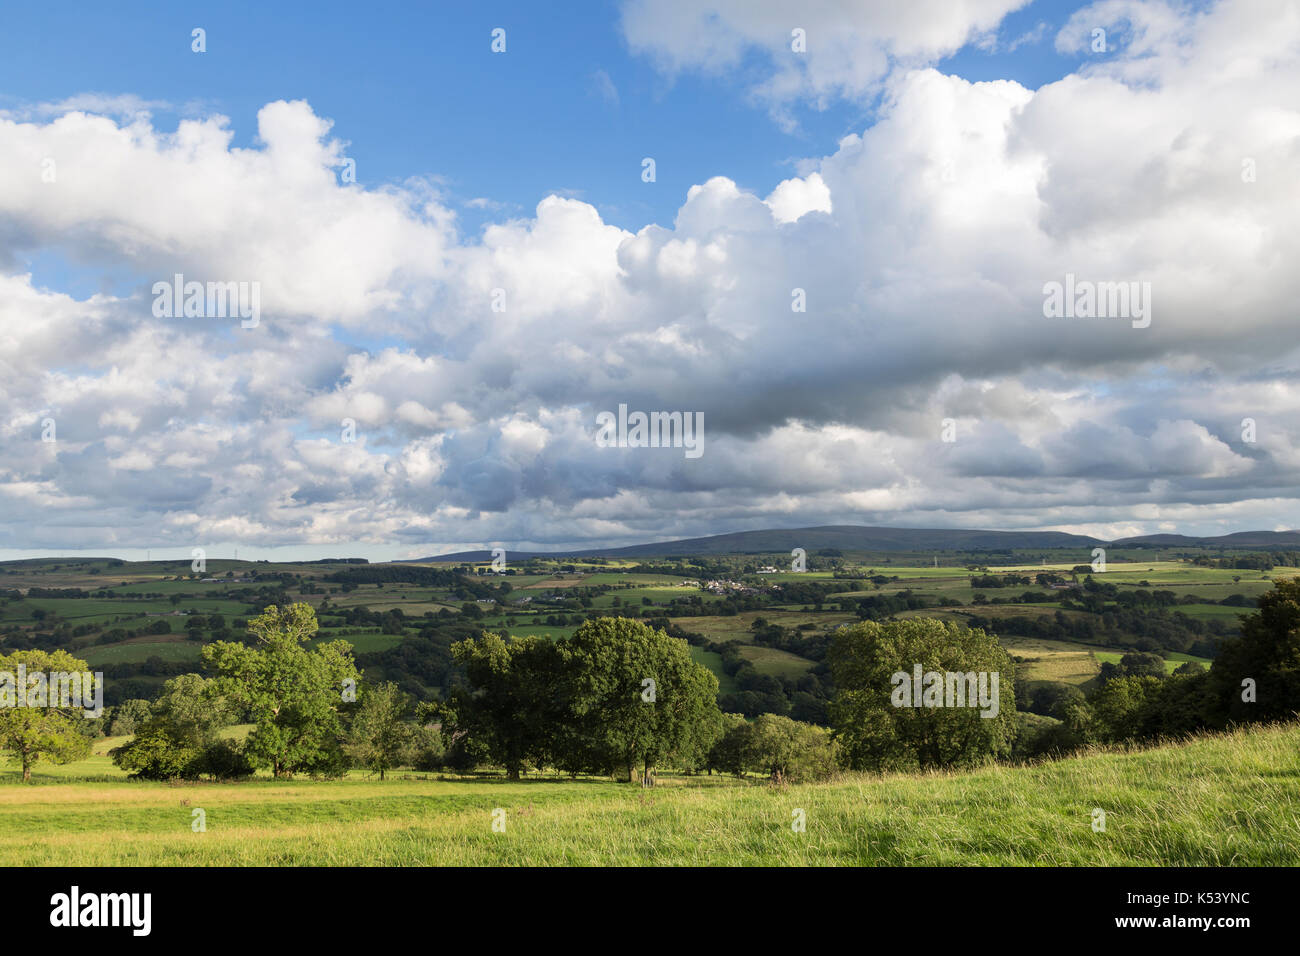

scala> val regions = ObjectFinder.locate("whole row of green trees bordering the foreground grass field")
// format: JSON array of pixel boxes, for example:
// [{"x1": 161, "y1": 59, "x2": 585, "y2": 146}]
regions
[{"x1": 10, "y1": 579, "x2": 1300, "y2": 782}]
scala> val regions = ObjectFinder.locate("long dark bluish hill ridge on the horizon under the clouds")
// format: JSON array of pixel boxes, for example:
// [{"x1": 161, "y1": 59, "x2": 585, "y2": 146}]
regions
[{"x1": 413, "y1": 524, "x2": 1300, "y2": 563}]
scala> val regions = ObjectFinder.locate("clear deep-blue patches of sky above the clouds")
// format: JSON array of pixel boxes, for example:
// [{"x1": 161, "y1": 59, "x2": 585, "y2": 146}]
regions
[{"x1": 0, "y1": 0, "x2": 1083, "y2": 240}]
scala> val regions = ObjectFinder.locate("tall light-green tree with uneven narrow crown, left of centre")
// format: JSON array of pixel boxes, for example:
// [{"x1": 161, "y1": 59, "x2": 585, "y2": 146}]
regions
[{"x1": 203, "y1": 604, "x2": 359, "y2": 777}]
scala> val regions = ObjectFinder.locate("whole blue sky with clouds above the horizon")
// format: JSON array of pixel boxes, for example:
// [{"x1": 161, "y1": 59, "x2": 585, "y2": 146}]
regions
[{"x1": 0, "y1": 0, "x2": 1300, "y2": 559}]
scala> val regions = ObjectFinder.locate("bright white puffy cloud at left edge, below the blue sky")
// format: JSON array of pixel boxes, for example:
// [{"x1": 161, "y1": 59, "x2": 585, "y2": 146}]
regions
[{"x1": 0, "y1": 101, "x2": 451, "y2": 320}]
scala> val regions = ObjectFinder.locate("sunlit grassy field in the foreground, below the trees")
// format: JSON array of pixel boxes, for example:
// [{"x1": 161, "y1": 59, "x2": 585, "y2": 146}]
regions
[{"x1": 0, "y1": 724, "x2": 1300, "y2": 866}]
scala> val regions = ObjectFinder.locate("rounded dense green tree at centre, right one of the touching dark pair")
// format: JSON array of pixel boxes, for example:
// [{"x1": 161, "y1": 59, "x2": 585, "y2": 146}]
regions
[{"x1": 558, "y1": 618, "x2": 718, "y2": 780}]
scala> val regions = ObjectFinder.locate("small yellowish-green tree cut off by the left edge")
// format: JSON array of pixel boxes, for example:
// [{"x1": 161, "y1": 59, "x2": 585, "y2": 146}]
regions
[{"x1": 0, "y1": 650, "x2": 94, "y2": 780}]
